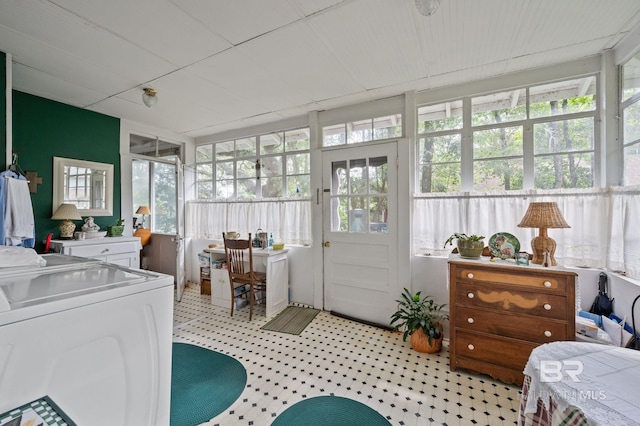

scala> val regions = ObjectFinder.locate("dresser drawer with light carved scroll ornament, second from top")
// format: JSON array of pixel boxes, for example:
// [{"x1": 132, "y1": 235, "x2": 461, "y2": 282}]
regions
[{"x1": 455, "y1": 282, "x2": 567, "y2": 320}]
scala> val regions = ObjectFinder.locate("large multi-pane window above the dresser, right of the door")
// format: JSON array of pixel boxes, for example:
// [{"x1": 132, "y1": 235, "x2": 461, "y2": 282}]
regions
[{"x1": 416, "y1": 76, "x2": 597, "y2": 193}]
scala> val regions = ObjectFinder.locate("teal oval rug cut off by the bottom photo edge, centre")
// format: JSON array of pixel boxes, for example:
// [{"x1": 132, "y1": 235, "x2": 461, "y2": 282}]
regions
[{"x1": 271, "y1": 396, "x2": 391, "y2": 426}]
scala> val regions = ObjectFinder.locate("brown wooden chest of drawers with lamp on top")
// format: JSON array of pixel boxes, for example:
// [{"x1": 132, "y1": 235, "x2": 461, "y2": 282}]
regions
[{"x1": 449, "y1": 259, "x2": 577, "y2": 385}]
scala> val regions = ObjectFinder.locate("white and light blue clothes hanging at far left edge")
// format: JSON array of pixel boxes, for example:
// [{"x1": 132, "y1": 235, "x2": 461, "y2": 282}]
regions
[{"x1": 0, "y1": 170, "x2": 36, "y2": 248}]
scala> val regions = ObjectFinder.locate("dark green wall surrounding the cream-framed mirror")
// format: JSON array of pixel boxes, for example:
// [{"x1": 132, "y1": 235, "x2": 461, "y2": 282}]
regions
[{"x1": 13, "y1": 90, "x2": 121, "y2": 250}]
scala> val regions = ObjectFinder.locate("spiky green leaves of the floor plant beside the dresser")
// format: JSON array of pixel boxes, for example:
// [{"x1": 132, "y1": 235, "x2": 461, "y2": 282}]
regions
[{"x1": 391, "y1": 288, "x2": 449, "y2": 345}]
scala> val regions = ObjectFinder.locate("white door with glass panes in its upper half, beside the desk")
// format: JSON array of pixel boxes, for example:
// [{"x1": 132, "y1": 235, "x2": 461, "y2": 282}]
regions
[{"x1": 322, "y1": 142, "x2": 400, "y2": 325}]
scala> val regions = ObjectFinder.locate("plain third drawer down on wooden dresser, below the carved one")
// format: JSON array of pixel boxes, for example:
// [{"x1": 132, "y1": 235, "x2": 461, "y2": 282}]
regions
[{"x1": 454, "y1": 307, "x2": 569, "y2": 343}]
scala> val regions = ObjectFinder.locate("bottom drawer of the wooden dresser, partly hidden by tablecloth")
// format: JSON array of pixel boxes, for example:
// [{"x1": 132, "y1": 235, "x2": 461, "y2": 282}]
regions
[{"x1": 454, "y1": 330, "x2": 538, "y2": 371}]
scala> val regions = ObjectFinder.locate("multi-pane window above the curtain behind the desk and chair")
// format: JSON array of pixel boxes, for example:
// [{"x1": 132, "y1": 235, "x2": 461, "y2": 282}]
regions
[{"x1": 196, "y1": 128, "x2": 311, "y2": 201}]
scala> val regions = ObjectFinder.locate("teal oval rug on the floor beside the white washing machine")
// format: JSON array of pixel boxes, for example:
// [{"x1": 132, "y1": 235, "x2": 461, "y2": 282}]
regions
[{"x1": 170, "y1": 343, "x2": 247, "y2": 426}]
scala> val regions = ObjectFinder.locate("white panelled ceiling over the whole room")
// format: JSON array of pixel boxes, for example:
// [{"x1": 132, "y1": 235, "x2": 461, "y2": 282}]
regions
[{"x1": 0, "y1": 0, "x2": 640, "y2": 137}]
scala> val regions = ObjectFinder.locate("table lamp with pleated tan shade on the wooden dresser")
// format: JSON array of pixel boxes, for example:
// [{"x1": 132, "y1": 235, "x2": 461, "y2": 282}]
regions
[{"x1": 518, "y1": 202, "x2": 571, "y2": 266}]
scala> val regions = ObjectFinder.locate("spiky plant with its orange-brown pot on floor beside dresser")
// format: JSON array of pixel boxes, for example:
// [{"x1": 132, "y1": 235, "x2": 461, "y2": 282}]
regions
[{"x1": 391, "y1": 288, "x2": 449, "y2": 353}]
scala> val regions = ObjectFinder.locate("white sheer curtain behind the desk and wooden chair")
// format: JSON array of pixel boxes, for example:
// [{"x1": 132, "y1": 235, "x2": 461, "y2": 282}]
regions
[{"x1": 185, "y1": 200, "x2": 311, "y2": 245}]
